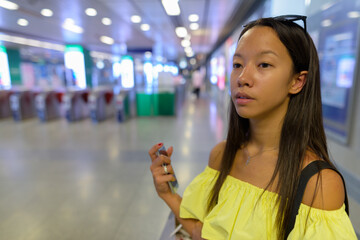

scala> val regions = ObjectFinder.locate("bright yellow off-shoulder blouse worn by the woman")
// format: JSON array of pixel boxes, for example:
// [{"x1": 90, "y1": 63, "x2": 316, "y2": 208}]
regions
[{"x1": 180, "y1": 166, "x2": 357, "y2": 240}]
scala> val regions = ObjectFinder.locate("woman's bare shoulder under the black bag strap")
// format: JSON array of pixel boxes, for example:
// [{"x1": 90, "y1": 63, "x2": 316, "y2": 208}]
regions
[{"x1": 302, "y1": 155, "x2": 345, "y2": 210}]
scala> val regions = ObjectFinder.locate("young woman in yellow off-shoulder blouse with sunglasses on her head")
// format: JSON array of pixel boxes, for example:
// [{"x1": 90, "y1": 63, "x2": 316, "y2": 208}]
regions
[{"x1": 149, "y1": 15, "x2": 356, "y2": 240}]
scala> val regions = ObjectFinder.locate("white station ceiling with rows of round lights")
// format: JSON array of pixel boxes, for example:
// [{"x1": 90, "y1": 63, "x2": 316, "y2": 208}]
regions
[{"x1": 0, "y1": 0, "x2": 255, "y2": 60}]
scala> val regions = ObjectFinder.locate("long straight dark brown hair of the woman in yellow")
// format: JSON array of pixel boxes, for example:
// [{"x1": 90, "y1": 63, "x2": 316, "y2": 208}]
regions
[{"x1": 208, "y1": 18, "x2": 333, "y2": 239}]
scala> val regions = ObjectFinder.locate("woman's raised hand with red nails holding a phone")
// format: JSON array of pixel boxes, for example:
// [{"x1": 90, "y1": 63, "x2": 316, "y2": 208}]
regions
[{"x1": 149, "y1": 143, "x2": 175, "y2": 198}]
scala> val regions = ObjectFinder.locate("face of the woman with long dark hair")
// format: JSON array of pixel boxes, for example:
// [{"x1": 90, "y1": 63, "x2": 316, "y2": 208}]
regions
[{"x1": 230, "y1": 26, "x2": 295, "y2": 122}]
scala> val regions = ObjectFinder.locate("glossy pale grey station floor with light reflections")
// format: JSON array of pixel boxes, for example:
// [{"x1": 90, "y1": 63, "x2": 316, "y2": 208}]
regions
[{"x1": 0, "y1": 95, "x2": 226, "y2": 240}]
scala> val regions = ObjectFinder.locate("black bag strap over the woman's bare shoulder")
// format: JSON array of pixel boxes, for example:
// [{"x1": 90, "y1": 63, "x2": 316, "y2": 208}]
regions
[{"x1": 284, "y1": 160, "x2": 349, "y2": 239}]
